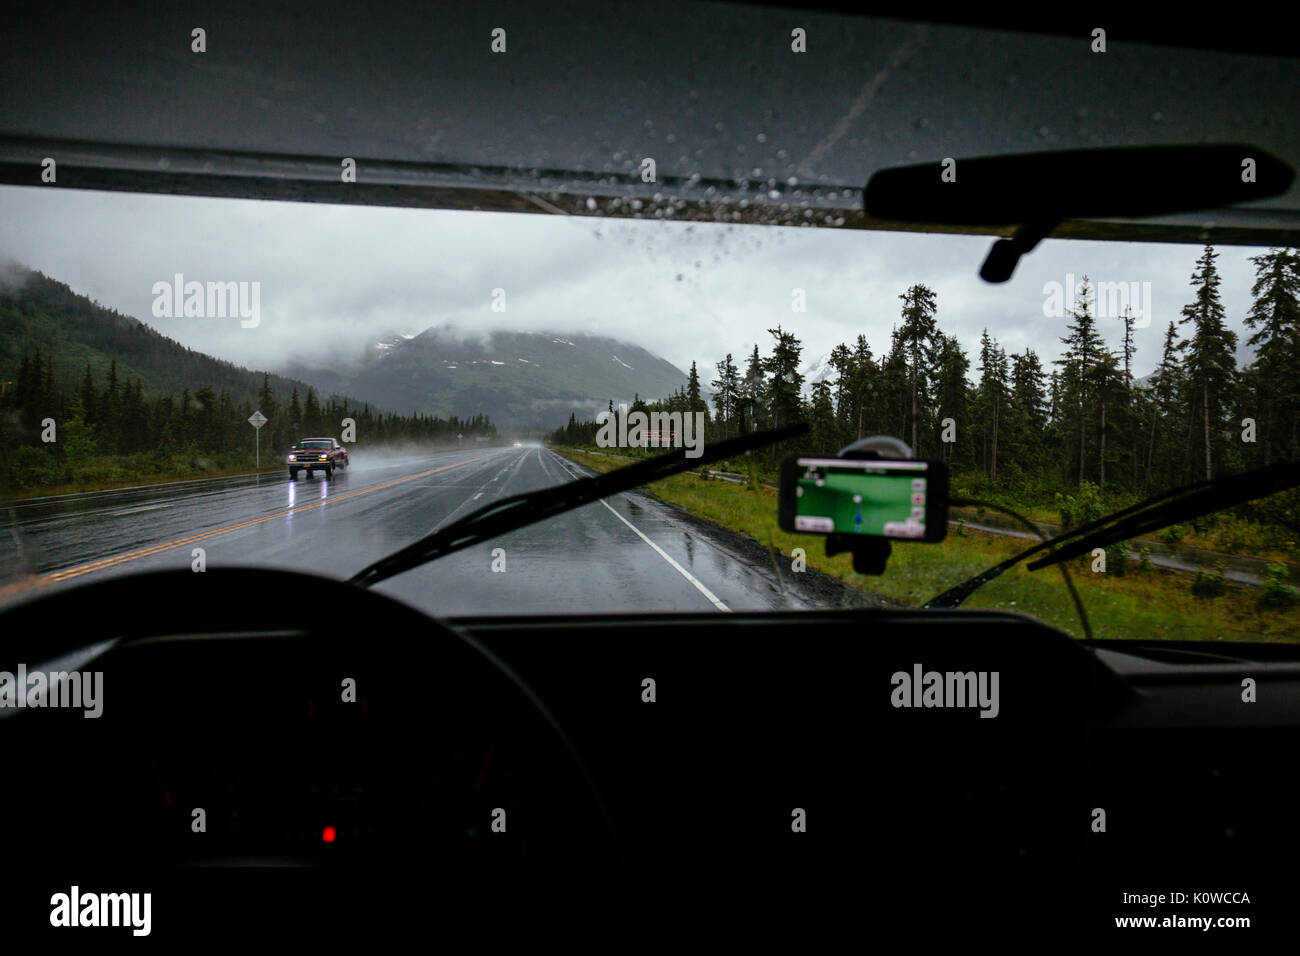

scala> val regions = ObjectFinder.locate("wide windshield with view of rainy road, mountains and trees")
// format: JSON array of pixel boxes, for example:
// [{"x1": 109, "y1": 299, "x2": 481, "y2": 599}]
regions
[{"x1": 0, "y1": 187, "x2": 1300, "y2": 641}]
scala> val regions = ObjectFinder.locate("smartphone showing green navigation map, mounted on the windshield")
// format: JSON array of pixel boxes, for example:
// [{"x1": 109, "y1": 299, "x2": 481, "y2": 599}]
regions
[{"x1": 794, "y1": 458, "x2": 926, "y2": 537}]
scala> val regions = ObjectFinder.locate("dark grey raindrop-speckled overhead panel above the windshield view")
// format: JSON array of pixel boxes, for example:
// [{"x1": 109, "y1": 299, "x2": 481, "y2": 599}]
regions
[{"x1": 0, "y1": 0, "x2": 1300, "y2": 245}]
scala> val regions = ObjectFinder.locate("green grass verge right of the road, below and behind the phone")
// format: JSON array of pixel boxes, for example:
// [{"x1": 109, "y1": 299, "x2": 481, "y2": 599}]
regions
[{"x1": 554, "y1": 447, "x2": 1300, "y2": 643}]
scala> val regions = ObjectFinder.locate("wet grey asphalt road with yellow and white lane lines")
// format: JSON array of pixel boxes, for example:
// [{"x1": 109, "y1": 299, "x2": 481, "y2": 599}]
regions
[{"x1": 0, "y1": 445, "x2": 820, "y2": 615}]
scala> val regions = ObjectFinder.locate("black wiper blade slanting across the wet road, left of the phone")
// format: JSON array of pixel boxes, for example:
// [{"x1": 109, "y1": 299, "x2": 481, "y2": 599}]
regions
[{"x1": 348, "y1": 423, "x2": 809, "y2": 588}]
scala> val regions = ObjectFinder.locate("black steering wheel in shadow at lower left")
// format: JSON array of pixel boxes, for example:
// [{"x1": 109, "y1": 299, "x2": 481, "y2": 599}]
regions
[{"x1": 0, "y1": 567, "x2": 612, "y2": 865}]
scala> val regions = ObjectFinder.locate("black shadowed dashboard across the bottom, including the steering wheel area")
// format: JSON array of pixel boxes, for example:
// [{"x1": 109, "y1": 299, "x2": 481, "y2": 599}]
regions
[{"x1": 0, "y1": 570, "x2": 1300, "y2": 931}]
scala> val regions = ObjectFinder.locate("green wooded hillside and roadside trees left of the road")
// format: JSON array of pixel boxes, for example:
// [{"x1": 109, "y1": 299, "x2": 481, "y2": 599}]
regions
[{"x1": 0, "y1": 272, "x2": 497, "y2": 498}]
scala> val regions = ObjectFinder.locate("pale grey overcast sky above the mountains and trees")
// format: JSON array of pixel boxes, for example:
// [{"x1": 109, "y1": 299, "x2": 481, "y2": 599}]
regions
[{"x1": 0, "y1": 186, "x2": 1260, "y2": 382}]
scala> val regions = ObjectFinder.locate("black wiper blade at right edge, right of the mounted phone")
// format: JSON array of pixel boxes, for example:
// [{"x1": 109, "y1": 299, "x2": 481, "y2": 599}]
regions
[{"x1": 924, "y1": 462, "x2": 1300, "y2": 607}]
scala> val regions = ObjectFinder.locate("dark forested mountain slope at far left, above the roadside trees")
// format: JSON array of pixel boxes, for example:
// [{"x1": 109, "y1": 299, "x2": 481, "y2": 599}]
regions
[{"x1": 0, "y1": 263, "x2": 358, "y2": 405}]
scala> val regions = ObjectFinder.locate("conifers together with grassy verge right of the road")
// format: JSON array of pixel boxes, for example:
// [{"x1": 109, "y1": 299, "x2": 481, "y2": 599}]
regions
[{"x1": 551, "y1": 246, "x2": 1300, "y2": 639}]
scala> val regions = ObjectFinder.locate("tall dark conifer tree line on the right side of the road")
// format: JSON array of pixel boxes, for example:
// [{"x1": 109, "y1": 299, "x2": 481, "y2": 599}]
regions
[{"x1": 553, "y1": 246, "x2": 1300, "y2": 496}]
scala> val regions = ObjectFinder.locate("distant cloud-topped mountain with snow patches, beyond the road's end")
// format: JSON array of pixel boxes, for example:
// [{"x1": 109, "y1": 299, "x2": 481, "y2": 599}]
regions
[{"x1": 281, "y1": 326, "x2": 686, "y2": 429}]
